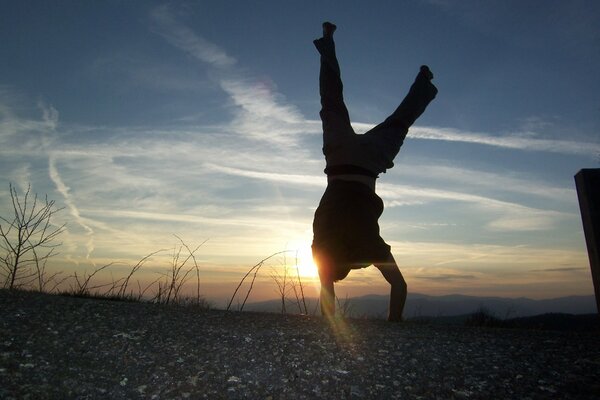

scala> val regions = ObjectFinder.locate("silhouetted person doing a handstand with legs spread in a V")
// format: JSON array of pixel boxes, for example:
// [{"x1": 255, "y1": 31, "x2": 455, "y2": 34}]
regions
[{"x1": 312, "y1": 22, "x2": 437, "y2": 321}]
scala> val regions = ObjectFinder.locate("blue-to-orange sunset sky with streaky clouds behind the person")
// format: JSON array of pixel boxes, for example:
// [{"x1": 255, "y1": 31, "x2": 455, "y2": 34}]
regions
[{"x1": 0, "y1": 0, "x2": 600, "y2": 305}]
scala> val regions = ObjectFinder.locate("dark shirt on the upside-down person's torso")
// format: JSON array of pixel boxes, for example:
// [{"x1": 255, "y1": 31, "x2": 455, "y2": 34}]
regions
[{"x1": 312, "y1": 180, "x2": 391, "y2": 281}]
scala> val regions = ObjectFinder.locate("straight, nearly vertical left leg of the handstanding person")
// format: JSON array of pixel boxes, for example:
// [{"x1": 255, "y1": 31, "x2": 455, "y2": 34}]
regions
[{"x1": 313, "y1": 22, "x2": 354, "y2": 154}]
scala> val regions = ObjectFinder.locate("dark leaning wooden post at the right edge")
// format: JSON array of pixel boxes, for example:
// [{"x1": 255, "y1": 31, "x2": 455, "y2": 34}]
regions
[{"x1": 575, "y1": 168, "x2": 600, "y2": 313}]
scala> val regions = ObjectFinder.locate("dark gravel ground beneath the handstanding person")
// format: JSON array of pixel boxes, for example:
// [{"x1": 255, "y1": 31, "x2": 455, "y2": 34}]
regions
[{"x1": 0, "y1": 291, "x2": 600, "y2": 399}]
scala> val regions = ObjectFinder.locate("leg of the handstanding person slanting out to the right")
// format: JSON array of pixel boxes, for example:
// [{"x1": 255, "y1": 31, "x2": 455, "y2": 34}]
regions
[{"x1": 365, "y1": 65, "x2": 437, "y2": 166}]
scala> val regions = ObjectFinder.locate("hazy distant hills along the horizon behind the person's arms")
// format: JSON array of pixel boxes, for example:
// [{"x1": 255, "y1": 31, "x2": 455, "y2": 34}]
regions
[{"x1": 244, "y1": 293, "x2": 597, "y2": 319}]
